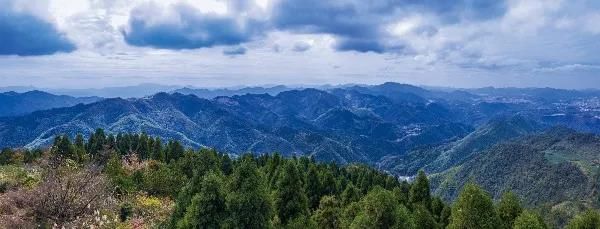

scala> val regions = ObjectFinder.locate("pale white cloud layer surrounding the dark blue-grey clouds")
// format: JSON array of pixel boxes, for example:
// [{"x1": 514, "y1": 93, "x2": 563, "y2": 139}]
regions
[{"x1": 0, "y1": 0, "x2": 600, "y2": 87}]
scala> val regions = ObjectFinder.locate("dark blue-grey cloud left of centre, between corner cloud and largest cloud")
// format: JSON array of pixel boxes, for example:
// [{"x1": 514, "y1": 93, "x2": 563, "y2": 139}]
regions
[{"x1": 122, "y1": 4, "x2": 263, "y2": 49}]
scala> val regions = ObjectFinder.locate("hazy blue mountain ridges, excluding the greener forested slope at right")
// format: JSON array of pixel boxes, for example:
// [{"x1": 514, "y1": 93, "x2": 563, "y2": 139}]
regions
[{"x1": 0, "y1": 83, "x2": 600, "y2": 165}]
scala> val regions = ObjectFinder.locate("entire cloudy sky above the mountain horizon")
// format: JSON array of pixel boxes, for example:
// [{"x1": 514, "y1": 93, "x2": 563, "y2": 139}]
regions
[{"x1": 0, "y1": 0, "x2": 600, "y2": 88}]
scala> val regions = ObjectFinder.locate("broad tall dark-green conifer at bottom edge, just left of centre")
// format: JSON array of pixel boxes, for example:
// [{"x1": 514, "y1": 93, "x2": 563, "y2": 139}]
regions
[{"x1": 227, "y1": 160, "x2": 273, "y2": 229}]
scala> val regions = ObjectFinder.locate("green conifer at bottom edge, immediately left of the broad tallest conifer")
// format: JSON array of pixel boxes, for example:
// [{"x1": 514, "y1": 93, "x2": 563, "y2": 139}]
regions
[{"x1": 177, "y1": 173, "x2": 227, "y2": 228}]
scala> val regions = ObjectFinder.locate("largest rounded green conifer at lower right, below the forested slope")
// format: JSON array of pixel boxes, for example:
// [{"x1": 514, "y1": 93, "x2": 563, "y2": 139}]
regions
[{"x1": 448, "y1": 183, "x2": 500, "y2": 229}]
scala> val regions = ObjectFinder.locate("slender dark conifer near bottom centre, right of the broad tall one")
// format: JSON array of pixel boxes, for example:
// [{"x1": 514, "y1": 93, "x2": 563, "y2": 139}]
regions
[{"x1": 275, "y1": 161, "x2": 308, "y2": 225}]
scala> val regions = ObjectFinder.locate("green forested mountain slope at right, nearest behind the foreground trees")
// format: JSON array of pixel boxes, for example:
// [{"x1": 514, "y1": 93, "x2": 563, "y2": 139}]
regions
[{"x1": 432, "y1": 128, "x2": 600, "y2": 206}]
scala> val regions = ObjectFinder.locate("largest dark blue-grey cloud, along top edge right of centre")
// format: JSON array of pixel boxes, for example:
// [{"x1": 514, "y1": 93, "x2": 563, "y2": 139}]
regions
[{"x1": 272, "y1": 0, "x2": 506, "y2": 53}]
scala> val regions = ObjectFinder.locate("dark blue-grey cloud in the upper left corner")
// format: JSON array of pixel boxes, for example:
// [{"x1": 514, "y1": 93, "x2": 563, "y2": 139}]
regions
[{"x1": 0, "y1": 1, "x2": 75, "y2": 56}]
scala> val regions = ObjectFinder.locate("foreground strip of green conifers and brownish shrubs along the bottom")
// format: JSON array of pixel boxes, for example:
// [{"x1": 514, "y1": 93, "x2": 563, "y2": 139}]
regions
[{"x1": 0, "y1": 130, "x2": 600, "y2": 229}]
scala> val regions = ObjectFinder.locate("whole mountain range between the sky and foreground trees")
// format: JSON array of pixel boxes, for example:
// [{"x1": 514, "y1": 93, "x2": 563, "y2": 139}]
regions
[{"x1": 0, "y1": 83, "x2": 600, "y2": 209}]
